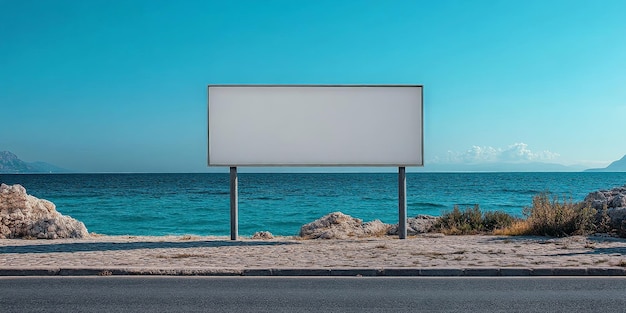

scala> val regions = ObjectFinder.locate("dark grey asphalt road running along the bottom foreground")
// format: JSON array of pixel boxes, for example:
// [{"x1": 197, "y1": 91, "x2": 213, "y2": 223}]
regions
[{"x1": 0, "y1": 276, "x2": 626, "y2": 313}]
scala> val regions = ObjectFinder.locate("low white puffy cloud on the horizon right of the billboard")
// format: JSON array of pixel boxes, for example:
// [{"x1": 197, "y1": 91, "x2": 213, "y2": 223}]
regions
[{"x1": 435, "y1": 143, "x2": 559, "y2": 164}]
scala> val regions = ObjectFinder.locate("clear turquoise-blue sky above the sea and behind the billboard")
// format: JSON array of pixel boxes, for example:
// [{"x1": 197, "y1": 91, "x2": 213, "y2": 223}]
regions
[{"x1": 0, "y1": 0, "x2": 626, "y2": 172}]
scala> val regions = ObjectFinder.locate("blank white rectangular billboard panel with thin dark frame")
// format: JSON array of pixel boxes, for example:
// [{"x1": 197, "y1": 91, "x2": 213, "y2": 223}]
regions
[{"x1": 208, "y1": 85, "x2": 423, "y2": 166}]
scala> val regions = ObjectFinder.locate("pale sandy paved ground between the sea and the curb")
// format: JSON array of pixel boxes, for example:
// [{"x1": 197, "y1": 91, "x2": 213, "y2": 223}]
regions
[{"x1": 0, "y1": 234, "x2": 626, "y2": 269}]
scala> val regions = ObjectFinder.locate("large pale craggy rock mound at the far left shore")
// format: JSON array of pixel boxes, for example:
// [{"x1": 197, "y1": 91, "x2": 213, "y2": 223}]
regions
[{"x1": 0, "y1": 184, "x2": 89, "y2": 239}]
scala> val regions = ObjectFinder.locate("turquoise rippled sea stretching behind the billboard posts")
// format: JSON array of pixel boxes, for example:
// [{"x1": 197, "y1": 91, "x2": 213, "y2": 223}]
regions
[{"x1": 0, "y1": 172, "x2": 626, "y2": 236}]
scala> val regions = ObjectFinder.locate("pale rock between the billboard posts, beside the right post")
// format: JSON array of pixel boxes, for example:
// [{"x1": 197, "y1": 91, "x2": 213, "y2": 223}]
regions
[{"x1": 300, "y1": 212, "x2": 390, "y2": 239}]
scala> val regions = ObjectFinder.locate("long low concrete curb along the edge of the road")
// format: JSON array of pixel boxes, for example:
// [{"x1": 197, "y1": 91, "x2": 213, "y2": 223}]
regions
[{"x1": 0, "y1": 267, "x2": 626, "y2": 277}]
